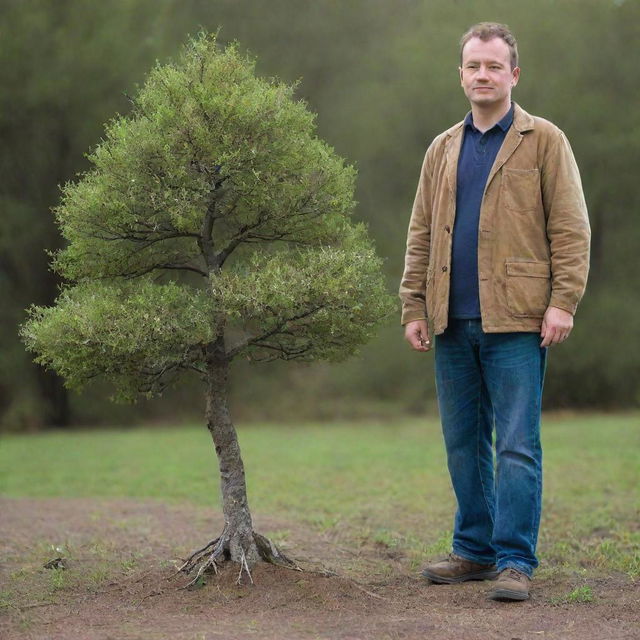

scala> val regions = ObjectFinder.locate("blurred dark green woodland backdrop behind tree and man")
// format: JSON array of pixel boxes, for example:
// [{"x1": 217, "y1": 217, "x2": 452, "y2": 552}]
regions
[{"x1": 0, "y1": 0, "x2": 640, "y2": 429}]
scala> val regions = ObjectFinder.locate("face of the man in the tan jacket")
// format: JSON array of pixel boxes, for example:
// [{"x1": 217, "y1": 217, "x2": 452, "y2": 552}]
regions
[{"x1": 460, "y1": 38, "x2": 520, "y2": 107}]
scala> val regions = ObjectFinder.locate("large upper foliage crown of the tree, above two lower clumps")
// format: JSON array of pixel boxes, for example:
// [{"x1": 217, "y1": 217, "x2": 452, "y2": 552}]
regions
[{"x1": 55, "y1": 34, "x2": 355, "y2": 280}]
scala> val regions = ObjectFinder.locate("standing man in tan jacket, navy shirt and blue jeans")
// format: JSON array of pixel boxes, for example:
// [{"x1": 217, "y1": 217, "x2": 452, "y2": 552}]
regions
[{"x1": 400, "y1": 23, "x2": 590, "y2": 600}]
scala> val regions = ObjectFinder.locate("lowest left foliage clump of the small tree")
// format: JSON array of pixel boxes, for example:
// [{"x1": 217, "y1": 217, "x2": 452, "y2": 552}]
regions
[{"x1": 22, "y1": 279, "x2": 216, "y2": 400}]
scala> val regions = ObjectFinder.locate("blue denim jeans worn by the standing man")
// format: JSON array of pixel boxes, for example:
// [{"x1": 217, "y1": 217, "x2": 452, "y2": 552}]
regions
[{"x1": 435, "y1": 320, "x2": 547, "y2": 576}]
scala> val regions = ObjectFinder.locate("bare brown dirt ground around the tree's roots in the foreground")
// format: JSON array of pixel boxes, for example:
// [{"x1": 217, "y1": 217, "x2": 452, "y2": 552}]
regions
[{"x1": 0, "y1": 498, "x2": 640, "y2": 640}]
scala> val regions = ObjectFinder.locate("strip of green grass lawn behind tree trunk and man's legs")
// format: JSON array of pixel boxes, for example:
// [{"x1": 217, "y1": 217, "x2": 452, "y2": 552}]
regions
[{"x1": 0, "y1": 414, "x2": 640, "y2": 576}]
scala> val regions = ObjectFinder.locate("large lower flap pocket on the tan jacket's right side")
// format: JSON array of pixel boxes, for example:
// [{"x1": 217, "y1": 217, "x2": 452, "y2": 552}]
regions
[{"x1": 505, "y1": 259, "x2": 551, "y2": 318}]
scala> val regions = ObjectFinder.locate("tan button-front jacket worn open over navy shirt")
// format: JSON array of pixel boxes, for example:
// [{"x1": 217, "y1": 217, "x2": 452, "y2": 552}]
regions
[{"x1": 400, "y1": 104, "x2": 591, "y2": 334}]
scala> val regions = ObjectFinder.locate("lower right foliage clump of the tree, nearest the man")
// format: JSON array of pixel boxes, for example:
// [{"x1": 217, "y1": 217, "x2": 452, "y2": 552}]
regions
[{"x1": 212, "y1": 226, "x2": 389, "y2": 361}]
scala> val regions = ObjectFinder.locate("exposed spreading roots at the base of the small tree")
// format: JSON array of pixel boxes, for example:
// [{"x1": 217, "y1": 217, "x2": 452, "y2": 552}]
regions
[{"x1": 174, "y1": 531, "x2": 302, "y2": 589}]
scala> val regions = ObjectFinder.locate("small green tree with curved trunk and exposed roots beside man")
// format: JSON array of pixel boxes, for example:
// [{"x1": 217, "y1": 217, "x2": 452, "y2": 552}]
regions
[{"x1": 21, "y1": 33, "x2": 391, "y2": 580}]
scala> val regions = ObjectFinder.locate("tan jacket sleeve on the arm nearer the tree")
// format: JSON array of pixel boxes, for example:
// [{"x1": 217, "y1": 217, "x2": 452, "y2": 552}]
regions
[{"x1": 399, "y1": 150, "x2": 431, "y2": 325}]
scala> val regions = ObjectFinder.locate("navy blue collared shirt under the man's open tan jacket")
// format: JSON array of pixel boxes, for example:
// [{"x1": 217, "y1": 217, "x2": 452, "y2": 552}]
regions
[{"x1": 449, "y1": 103, "x2": 513, "y2": 319}]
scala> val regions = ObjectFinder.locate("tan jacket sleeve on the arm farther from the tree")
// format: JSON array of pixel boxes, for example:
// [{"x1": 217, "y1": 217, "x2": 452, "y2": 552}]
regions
[{"x1": 541, "y1": 131, "x2": 591, "y2": 314}]
